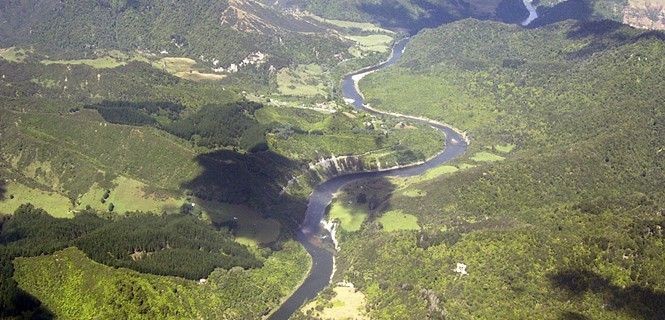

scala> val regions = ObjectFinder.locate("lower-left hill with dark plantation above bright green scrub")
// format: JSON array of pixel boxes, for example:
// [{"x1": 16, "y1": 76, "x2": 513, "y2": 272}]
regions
[{"x1": 0, "y1": 205, "x2": 307, "y2": 319}]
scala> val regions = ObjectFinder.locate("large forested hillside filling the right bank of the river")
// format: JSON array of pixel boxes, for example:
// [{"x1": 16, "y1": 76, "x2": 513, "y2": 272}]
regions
[{"x1": 303, "y1": 20, "x2": 665, "y2": 319}]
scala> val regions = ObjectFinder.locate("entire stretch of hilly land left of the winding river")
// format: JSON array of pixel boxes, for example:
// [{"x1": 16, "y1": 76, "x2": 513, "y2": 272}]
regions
[{"x1": 0, "y1": 11, "x2": 443, "y2": 319}]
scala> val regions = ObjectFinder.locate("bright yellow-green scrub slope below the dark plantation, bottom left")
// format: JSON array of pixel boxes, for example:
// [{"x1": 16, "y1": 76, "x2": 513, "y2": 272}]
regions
[{"x1": 14, "y1": 241, "x2": 311, "y2": 319}]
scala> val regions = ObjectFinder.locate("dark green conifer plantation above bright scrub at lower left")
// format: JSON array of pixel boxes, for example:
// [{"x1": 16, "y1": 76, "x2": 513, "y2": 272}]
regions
[{"x1": 0, "y1": 205, "x2": 261, "y2": 316}]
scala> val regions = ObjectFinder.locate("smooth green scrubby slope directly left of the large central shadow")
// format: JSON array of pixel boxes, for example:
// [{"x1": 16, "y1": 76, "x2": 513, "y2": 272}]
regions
[{"x1": 20, "y1": 114, "x2": 200, "y2": 190}]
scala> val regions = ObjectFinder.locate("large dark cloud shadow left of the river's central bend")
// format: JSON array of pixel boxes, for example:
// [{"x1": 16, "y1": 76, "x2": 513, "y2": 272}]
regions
[{"x1": 182, "y1": 150, "x2": 307, "y2": 234}]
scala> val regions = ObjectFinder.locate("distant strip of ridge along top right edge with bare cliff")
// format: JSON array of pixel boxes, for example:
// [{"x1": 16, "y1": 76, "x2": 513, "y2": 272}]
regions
[{"x1": 263, "y1": 0, "x2": 665, "y2": 32}]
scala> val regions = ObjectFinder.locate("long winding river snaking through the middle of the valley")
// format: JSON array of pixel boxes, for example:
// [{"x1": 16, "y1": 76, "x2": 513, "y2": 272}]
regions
[{"x1": 268, "y1": 38, "x2": 468, "y2": 320}]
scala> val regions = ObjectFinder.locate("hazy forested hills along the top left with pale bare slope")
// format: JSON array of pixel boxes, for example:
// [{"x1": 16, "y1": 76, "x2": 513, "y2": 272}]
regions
[{"x1": 0, "y1": 0, "x2": 349, "y2": 68}]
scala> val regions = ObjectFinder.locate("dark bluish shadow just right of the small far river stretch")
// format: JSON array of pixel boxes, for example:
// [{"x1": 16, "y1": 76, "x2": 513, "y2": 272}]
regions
[{"x1": 528, "y1": 0, "x2": 593, "y2": 28}]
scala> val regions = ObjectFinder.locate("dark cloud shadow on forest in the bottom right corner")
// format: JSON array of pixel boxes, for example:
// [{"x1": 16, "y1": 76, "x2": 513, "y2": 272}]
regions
[{"x1": 550, "y1": 270, "x2": 665, "y2": 319}]
